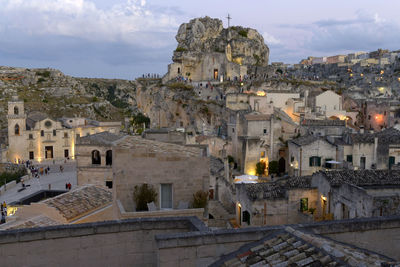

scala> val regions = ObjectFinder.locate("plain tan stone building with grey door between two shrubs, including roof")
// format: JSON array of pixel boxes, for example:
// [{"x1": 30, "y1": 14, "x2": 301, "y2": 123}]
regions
[{"x1": 112, "y1": 136, "x2": 210, "y2": 221}]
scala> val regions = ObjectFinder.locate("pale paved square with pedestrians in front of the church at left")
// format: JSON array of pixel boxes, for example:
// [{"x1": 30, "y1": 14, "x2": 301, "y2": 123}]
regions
[{"x1": 0, "y1": 162, "x2": 77, "y2": 203}]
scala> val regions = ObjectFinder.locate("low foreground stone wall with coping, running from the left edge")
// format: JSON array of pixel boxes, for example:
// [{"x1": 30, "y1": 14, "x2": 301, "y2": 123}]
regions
[{"x1": 0, "y1": 217, "x2": 207, "y2": 266}]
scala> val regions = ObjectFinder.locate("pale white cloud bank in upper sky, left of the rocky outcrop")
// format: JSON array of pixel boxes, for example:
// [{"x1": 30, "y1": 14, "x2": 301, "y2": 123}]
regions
[{"x1": 0, "y1": 0, "x2": 179, "y2": 47}]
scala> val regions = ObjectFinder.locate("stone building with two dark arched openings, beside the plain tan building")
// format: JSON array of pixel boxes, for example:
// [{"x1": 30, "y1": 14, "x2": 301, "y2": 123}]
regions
[{"x1": 75, "y1": 132, "x2": 123, "y2": 188}]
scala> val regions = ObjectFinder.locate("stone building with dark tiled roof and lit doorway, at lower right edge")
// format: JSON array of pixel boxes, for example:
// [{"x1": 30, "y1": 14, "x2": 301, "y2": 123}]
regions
[{"x1": 311, "y1": 170, "x2": 400, "y2": 220}]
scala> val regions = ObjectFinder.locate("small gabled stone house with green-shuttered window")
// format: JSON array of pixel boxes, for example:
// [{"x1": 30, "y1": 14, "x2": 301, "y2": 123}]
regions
[{"x1": 288, "y1": 135, "x2": 339, "y2": 176}]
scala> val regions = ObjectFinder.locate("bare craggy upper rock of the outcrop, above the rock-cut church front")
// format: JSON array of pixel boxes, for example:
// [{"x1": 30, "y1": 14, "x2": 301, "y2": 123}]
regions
[{"x1": 173, "y1": 17, "x2": 269, "y2": 66}]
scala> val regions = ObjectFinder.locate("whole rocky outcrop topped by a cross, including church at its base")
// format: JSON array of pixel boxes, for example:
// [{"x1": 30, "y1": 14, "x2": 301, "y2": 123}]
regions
[{"x1": 164, "y1": 17, "x2": 269, "y2": 81}]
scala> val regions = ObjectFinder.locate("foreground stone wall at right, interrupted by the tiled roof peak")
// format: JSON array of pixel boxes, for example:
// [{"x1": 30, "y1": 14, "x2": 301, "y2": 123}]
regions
[{"x1": 155, "y1": 216, "x2": 400, "y2": 266}]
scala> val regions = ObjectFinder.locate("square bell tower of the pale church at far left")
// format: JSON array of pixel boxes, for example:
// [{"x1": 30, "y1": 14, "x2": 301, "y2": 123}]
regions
[{"x1": 7, "y1": 96, "x2": 26, "y2": 162}]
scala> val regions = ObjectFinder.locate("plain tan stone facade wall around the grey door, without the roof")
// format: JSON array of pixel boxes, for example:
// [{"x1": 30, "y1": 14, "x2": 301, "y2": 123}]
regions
[{"x1": 113, "y1": 147, "x2": 210, "y2": 212}]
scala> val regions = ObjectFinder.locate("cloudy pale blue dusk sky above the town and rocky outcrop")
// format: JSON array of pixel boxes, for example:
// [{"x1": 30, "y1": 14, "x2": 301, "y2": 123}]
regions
[{"x1": 0, "y1": 0, "x2": 400, "y2": 79}]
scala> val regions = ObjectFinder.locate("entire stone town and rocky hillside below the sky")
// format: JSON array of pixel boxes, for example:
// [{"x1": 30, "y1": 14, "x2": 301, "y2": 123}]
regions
[{"x1": 0, "y1": 17, "x2": 400, "y2": 266}]
